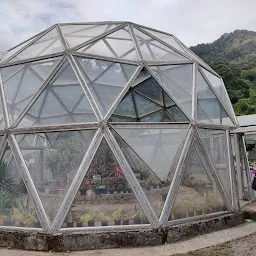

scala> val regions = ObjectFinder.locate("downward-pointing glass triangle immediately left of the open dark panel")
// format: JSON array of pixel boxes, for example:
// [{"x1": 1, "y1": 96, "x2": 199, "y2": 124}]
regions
[{"x1": 76, "y1": 58, "x2": 137, "y2": 116}]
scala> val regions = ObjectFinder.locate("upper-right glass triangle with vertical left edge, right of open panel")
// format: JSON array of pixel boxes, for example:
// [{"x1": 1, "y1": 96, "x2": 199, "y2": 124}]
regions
[{"x1": 196, "y1": 71, "x2": 234, "y2": 126}]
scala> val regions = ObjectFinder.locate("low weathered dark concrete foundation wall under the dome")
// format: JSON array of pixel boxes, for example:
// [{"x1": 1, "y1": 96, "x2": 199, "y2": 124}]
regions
[{"x1": 0, "y1": 213, "x2": 244, "y2": 251}]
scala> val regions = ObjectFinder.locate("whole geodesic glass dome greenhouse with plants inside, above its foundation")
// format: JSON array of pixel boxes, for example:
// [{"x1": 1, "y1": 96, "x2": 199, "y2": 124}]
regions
[{"x1": 0, "y1": 22, "x2": 237, "y2": 232}]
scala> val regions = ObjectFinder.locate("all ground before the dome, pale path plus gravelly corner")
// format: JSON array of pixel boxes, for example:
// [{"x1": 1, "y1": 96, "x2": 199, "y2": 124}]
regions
[{"x1": 0, "y1": 222, "x2": 256, "y2": 256}]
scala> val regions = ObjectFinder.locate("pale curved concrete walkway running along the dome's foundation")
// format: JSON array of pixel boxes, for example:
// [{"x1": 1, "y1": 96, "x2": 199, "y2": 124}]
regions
[{"x1": 0, "y1": 222, "x2": 256, "y2": 256}]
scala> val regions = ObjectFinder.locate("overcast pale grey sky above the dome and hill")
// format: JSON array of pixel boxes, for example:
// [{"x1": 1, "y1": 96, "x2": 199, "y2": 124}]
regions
[{"x1": 0, "y1": 0, "x2": 256, "y2": 51}]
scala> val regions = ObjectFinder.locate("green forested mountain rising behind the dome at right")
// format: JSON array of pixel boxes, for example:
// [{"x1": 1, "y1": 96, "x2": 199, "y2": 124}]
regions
[{"x1": 190, "y1": 30, "x2": 256, "y2": 115}]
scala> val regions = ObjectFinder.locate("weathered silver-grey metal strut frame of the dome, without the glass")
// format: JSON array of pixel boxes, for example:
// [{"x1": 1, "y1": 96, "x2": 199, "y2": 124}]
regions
[{"x1": 0, "y1": 22, "x2": 239, "y2": 232}]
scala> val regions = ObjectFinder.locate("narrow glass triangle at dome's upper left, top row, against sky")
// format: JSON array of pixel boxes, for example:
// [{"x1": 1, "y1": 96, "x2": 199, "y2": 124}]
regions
[{"x1": 8, "y1": 28, "x2": 64, "y2": 62}]
